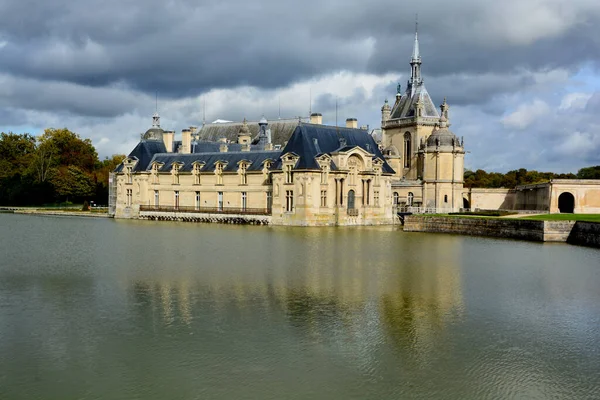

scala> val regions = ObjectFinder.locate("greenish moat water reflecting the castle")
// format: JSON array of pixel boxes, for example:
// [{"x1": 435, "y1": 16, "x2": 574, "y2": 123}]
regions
[{"x1": 0, "y1": 214, "x2": 600, "y2": 400}]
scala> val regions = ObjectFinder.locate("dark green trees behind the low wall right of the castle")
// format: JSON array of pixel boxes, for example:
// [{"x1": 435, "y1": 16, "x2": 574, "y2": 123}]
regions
[{"x1": 464, "y1": 165, "x2": 600, "y2": 188}]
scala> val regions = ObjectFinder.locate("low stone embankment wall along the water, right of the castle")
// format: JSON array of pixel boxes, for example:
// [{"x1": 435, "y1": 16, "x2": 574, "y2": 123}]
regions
[{"x1": 404, "y1": 215, "x2": 600, "y2": 247}]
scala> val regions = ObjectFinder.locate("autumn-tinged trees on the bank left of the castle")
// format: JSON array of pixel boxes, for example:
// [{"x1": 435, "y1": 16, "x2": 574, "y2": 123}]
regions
[{"x1": 0, "y1": 128, "x2": 125, "y2": 206}]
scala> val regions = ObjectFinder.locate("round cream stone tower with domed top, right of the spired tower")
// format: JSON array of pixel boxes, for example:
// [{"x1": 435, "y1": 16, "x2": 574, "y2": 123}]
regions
[{"x1": 419, "y1": 99, "x2": 465, "y2": 212}]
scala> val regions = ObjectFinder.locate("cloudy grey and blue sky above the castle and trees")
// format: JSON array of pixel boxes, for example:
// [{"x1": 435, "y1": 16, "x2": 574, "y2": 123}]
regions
[{"x1": 0, "y1": 0, "x2": 600, "y2": 172}]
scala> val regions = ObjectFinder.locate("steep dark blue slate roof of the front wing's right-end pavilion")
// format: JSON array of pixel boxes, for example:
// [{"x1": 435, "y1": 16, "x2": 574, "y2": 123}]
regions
[{"x1": 281, "y1": 123, "x2": 394, "y2": 174}]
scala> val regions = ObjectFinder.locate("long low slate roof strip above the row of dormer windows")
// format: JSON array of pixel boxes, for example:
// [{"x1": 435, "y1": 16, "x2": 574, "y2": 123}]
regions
[{"x1": 146, "y1": 151, "x2": 281, "y2": 172}]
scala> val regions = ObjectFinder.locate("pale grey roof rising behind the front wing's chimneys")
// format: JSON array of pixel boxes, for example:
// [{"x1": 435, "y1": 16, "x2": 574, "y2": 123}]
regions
[{"x1": 197, "y1": 119, "x2": 298, "y2": 146}]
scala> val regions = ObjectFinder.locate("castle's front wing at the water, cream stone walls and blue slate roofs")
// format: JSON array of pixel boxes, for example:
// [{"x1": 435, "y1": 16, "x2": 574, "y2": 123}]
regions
[{"x1": 112, "y1": 120, "x2": 394, "y2": 226}]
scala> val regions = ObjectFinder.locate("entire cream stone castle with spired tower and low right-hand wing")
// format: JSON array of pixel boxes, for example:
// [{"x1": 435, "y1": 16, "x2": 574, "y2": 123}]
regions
[{"x1": 109, "y1": 27, "x2": 600, "y2": 226}]
